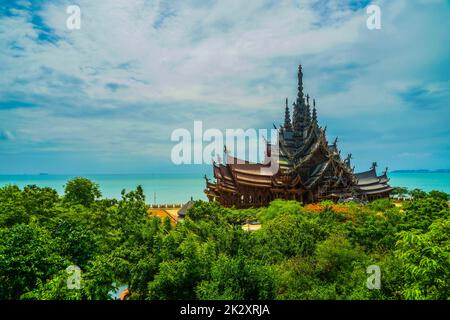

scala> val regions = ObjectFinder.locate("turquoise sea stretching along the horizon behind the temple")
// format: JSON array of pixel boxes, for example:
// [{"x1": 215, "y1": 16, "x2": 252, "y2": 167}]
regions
[{"x1": 0, "y1": 172, "x2": 450, "y2": 204}]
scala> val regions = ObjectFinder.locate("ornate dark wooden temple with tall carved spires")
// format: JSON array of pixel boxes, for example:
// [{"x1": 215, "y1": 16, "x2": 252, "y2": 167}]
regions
[{"x1": 205, "y1": 65, "x2": 392, "y2": 208}]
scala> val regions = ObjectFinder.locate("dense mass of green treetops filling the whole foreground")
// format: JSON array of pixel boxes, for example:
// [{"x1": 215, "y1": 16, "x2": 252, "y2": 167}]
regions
[{"x1": 0, "y1": 182, "x2": 450, "y2": 300}]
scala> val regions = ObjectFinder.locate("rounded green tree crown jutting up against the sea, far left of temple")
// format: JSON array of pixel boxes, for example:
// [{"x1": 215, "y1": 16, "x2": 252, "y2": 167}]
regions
[{"x1": 64, "y1": 177, "x2": 102, "y2": 207}]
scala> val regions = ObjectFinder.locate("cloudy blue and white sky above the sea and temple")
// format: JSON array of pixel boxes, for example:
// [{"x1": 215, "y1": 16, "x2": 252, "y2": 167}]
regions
[{"x1": 0, "y1": 0, "x2": 450, "y2": 174}]
